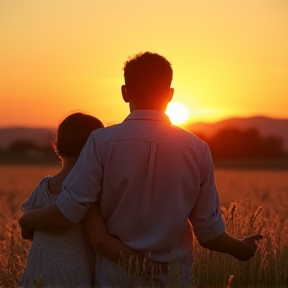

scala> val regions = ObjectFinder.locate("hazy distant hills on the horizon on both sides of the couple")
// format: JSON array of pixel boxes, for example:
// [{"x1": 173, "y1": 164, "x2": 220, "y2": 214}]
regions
[{"x1": 0, "y1": 116, "x2": 288, "y2": 151}]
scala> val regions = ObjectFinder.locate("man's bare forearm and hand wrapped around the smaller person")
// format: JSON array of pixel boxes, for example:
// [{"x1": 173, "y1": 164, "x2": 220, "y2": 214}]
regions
[{"x1": 19, "y1": 204, "x2": 74, "y2": 234}]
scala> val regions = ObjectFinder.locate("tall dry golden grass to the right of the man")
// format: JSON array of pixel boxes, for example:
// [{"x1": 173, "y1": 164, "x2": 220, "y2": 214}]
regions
[{"x1": 193, "y1": 170, "x2": 288, "y2": 288}]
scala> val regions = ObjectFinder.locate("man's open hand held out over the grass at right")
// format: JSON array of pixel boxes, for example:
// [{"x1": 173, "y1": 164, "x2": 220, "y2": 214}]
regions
[{"x1": 234, "y1": 234, "x2": 263, "y2": 261}]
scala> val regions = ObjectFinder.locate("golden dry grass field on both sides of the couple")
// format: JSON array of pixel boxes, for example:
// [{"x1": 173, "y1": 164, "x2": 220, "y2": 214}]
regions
[{"x1": 0, "y1": 166, "x2": 288, "y2": 288}]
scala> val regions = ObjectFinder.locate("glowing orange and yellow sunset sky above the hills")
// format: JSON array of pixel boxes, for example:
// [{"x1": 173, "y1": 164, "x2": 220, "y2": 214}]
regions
[{"x1": 0, "y1": 0, "x2": 288, "y2": 127}]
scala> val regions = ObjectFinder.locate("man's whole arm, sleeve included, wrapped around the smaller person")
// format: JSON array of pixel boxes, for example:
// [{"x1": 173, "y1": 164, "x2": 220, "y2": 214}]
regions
[{"x1": 19, "y1": 134, "x2": 103, "y2": 232}]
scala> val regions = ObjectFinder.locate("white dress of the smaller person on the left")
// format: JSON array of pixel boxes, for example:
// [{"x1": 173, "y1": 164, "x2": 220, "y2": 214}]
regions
[{"x1": 19, "y1": 176, "x2": 95, "y2": 288}]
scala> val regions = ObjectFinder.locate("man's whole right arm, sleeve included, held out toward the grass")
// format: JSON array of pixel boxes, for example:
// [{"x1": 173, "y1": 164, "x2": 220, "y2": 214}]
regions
[{"x1": 189, "y1": 146, "x2": 262, "y2": 261}]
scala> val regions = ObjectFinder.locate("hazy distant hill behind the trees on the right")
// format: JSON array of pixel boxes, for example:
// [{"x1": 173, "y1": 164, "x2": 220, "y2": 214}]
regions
[{"x1": 185, "y1": 116, "x2": 288, "y2": 151}]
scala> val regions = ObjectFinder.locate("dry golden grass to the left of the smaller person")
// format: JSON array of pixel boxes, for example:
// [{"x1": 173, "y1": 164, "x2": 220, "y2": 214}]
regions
[{"x1": 0, "y1": 166, "x2": 59, "y2": 288}]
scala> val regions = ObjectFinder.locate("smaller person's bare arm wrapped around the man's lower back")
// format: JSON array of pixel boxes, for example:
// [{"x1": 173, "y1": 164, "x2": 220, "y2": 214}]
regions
[{"x1": 83, "y1": 203, "x2": 144, "y2": 263}]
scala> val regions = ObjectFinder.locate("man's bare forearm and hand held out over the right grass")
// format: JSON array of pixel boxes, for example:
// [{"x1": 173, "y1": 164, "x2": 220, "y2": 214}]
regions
[{"x1": 199, "y1": 232, "x2": 263, "y2": 261}]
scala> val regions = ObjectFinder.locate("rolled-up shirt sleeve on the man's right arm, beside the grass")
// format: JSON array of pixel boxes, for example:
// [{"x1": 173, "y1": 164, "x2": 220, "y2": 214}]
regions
[{"x1": 190, "y1": 146, "x2": 225, "y2": 243}]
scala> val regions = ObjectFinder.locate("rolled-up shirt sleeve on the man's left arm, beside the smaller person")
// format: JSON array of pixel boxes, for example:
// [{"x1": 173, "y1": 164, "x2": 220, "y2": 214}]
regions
[{"x1": 56, "y1": 131, "x2": 103, "y2": 224}]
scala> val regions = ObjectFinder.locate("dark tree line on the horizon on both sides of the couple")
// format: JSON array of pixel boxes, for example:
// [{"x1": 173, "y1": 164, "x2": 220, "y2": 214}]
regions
[{"x1": 0, "y1": 128, "x2": 288, "y2": 165}]
